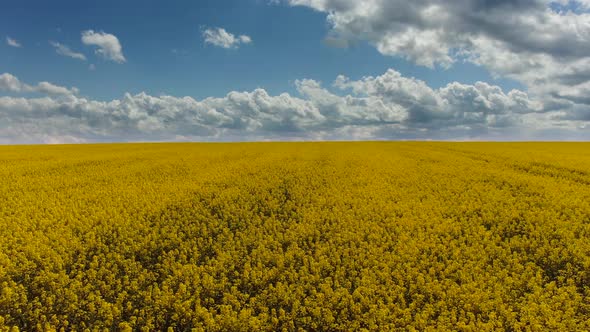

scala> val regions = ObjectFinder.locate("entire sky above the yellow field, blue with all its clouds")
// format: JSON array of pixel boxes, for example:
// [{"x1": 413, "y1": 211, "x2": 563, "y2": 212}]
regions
[{"x1": 0, "y1": 0, "x2": 590, "y2": 144}]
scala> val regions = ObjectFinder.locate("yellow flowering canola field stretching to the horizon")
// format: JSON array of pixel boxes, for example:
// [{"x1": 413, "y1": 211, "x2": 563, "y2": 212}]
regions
[{"x1": 0, "y1": 142, "x2": 590, "y2": 331}]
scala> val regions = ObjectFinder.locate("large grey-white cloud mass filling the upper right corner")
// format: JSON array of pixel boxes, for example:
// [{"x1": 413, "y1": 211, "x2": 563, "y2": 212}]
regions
[{"x1": 282, "y1": 0, "x2": 590, "y2": 111}]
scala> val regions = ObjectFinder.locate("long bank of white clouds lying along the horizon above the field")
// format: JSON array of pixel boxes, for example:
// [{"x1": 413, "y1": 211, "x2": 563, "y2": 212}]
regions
[{"x1": 0, "y1": 69, "x2": 590, "y2": 143}]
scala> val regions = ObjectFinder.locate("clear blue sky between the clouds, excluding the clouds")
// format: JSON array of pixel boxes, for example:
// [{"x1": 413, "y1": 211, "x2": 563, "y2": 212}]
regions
[{"x1": 0, "y1": 0, "x2": 522, "y2": 100}]
